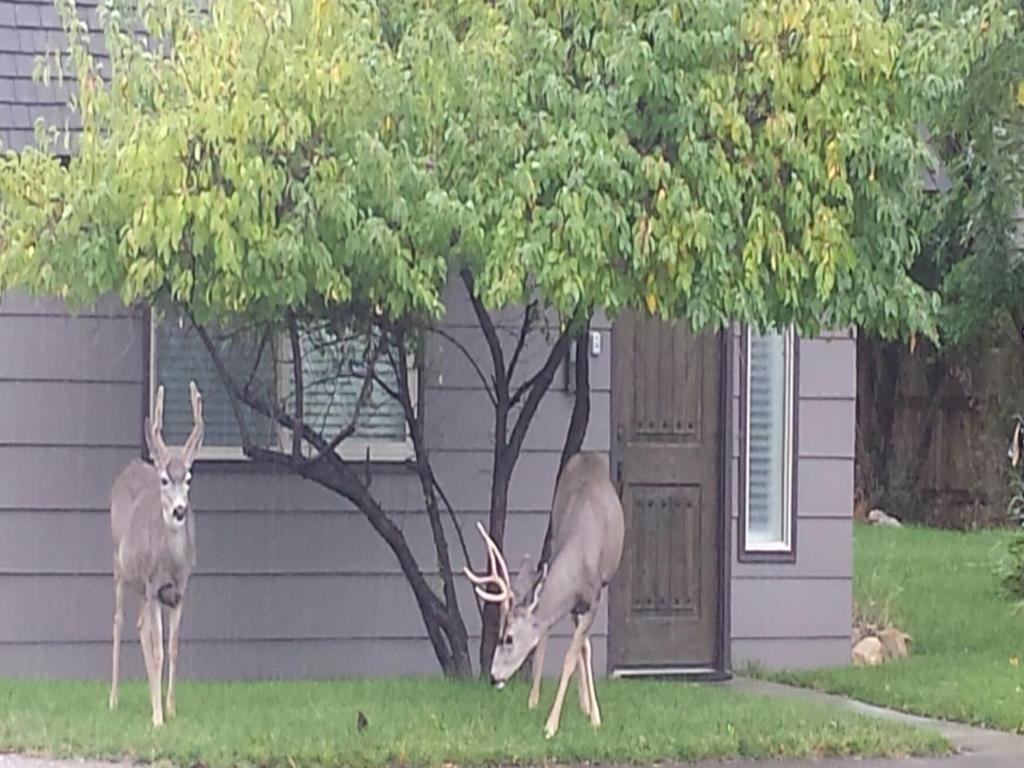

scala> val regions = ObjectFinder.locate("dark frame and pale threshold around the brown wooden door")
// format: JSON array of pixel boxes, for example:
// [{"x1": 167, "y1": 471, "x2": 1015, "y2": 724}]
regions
[{"x1": 605, "y1": 324, "x2": 738, "y2": 682}]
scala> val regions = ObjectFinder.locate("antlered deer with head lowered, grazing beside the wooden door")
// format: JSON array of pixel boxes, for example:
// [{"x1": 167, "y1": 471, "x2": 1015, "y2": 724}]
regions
[{"x1": 464, "y1": 452, "x2": 625, "y2": 738}]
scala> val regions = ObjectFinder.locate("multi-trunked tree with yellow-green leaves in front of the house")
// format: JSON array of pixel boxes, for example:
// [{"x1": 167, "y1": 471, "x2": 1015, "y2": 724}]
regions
[{"x1": 0, "y1": 0, "x2": 991, "y2": 675}]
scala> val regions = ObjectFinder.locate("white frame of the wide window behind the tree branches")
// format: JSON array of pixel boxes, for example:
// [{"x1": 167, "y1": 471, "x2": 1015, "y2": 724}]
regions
[{"x1": 146, "y1": 311, "x2": 420, "y2": 463}]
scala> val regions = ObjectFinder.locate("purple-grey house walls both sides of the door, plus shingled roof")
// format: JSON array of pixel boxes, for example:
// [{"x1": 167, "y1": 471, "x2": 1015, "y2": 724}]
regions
[{"x1": 0, "y1": 0, "x2": 856, "y2": 678}]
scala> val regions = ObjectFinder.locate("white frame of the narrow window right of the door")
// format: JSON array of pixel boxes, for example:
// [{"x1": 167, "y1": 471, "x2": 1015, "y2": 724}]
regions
[{"x1": 740, "y1": 327, "x2": 800, "y2": 555}]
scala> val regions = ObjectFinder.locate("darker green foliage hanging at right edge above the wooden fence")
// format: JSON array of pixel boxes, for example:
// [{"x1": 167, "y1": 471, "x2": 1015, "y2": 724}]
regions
[{"x1": 904, "y1": 0, "x2": 1024, "y2": 348}]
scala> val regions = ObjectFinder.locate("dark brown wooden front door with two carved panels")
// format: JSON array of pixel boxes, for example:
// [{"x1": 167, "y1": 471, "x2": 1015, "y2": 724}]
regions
[{"x1": 608, "y1": 313, "x2": 722, "y2": 670}]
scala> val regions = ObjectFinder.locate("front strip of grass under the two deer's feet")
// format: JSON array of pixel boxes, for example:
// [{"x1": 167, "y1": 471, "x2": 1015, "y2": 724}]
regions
[{"x1": 0, "y1": 680, "x2": 947, "y2": 768}]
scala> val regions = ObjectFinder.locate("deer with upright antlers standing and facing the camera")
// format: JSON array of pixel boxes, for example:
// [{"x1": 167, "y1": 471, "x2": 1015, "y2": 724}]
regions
[{"x1": 110, "y1": 382, "x2": 204, "y2": 726}]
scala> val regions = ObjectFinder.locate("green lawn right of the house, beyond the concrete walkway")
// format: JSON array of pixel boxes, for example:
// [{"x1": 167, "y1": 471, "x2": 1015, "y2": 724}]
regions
[{"x1": 772, "y1": 525, "x2": 1024, "y2": 732}]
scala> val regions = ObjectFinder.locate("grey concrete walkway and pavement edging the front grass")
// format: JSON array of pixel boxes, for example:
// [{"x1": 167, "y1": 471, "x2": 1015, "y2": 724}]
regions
[{"x1": 0, "y1": 678, "x2": 1024, "y2": 768}]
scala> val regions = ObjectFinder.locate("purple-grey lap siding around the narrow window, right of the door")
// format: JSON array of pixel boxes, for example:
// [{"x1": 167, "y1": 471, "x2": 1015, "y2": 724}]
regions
[{"x1": 730, "y1": 332, "x2": 856, "y2": 669}]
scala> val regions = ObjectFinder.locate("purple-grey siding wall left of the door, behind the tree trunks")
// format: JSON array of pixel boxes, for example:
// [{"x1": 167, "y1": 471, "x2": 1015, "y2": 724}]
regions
[{"x1": 0, "y1": 287, "x2": 610, "y2": 679}]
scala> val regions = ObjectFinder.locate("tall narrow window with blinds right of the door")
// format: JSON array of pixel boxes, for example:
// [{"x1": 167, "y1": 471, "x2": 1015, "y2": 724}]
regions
[{"x1": 740, "y1": 329, "x2": 796, "y2": 560}]
